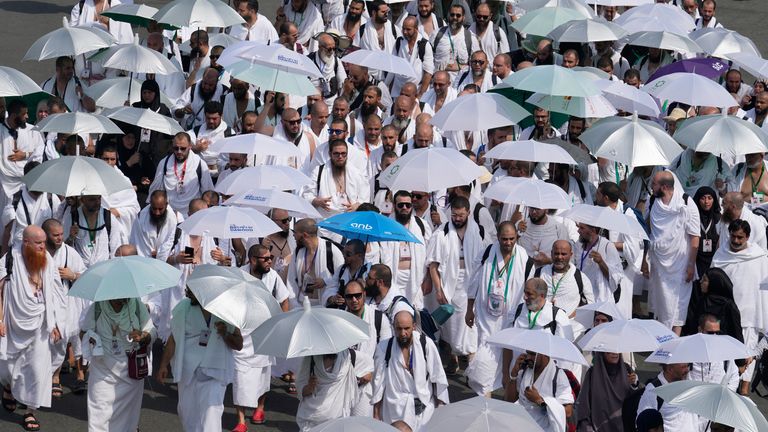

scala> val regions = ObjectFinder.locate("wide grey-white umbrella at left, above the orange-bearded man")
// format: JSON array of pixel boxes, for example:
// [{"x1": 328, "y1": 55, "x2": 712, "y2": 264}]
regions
[{"x1": 22, "y1": 156, "x2": 133, "y2": 197}]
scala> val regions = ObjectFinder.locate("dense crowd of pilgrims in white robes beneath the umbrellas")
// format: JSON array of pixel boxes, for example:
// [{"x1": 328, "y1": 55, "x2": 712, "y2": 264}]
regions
[{"x1": 0, "y1": 0, "x2": 768, "y2": 432}]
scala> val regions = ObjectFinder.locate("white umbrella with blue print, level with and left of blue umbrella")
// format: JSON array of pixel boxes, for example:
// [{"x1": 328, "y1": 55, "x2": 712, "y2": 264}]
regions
[{"x1": 179, "y1": 206, "x2": 280, "y2": 238}]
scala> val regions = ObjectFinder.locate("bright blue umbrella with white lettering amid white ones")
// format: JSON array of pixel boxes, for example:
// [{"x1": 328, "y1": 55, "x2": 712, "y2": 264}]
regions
[{"x1": 317, "y1": 211, "x2": 421, "y2": 243}]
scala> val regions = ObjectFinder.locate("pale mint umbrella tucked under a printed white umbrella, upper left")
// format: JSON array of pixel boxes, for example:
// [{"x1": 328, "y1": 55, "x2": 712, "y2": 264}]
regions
[{"x1": 227, "y1": 59, "x2": 317, "y2": 96}]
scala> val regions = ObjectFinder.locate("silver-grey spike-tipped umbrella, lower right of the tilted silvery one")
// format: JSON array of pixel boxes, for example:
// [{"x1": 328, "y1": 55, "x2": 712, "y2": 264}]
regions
[{"x1": 251, "y1": 296, "x2": 370, "y2": 358}]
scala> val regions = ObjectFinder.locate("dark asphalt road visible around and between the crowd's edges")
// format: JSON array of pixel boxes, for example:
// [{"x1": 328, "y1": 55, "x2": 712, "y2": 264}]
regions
[{"x1": 0, "y1": 0, "x2": 768, "y2": 432}]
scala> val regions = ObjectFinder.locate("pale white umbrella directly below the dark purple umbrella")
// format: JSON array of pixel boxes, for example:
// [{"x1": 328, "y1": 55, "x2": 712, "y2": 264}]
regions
[{"x1": 642, "y1": 72, "x2": 738, "y2": 108}]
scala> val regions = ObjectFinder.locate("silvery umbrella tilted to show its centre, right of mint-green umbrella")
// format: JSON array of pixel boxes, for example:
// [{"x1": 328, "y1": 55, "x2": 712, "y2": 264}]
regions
[{"x1": 187, "y1": 264, "x2": 282, "y2": 335}]
